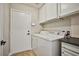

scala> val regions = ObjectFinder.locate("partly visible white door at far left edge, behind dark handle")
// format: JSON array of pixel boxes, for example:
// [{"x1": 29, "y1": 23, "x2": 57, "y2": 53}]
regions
[{"x1": 0, "y1": 4, "x2": 3, "y2": 56}]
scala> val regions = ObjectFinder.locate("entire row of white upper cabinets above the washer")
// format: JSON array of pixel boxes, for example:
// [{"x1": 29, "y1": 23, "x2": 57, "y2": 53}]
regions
[{"x1": 39, "y1": 3, "x2": 79, "y2": 23}]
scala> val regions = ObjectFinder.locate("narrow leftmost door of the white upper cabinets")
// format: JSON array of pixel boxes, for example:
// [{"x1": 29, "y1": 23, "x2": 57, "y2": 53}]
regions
[{"x1": 39, "y1": 5, "x2": 46, "y2": 22}]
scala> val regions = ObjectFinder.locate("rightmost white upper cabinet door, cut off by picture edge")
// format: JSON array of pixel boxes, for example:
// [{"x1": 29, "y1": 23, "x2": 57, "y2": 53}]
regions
[{"x1": 60, "y1": 3, "x2": 79, "y2": 16}]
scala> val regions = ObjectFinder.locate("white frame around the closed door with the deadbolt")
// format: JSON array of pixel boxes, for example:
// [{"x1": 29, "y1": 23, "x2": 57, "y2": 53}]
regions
[{"x1": 9, "y1": 8, "x2": 32, "y2": 55}]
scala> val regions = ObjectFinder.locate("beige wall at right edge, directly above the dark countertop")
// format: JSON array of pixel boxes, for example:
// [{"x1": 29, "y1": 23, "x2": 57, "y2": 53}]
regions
[{"x1": 71, "y1": 14, "x2": 79, "y2": 38}]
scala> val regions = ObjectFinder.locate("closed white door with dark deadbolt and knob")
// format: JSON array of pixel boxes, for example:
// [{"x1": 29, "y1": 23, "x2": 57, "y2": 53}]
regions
[{"x1": 10, "y1": 9, "x2": 31, "y2": 53}]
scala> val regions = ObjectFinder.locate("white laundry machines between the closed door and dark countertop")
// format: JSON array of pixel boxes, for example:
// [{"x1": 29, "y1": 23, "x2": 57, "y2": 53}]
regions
[{"x1": 32, "y1": 31, "x2": 63, "y2": 56}]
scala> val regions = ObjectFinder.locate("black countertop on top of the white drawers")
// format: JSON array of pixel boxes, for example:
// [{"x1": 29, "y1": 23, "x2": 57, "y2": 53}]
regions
[{"x1": 60, "y1": 37, "x2": 79, "y2": 46}]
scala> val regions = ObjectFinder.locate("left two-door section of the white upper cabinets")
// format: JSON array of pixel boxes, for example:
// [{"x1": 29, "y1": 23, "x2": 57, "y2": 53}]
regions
[{"x1": 39, "y1": 3, "x2": 57, "y2": 23}]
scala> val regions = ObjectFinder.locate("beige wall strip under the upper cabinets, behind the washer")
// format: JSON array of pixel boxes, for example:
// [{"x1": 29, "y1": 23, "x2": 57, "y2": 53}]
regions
[{"x1": 43, "y1": 17, "x2": 71, "y2": 30}]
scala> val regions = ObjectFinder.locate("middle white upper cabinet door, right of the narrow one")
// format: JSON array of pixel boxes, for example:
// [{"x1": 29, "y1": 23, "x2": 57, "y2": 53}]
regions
[{"x1": 46, "y1": 3, "x2": 57, "y2": 20}]
